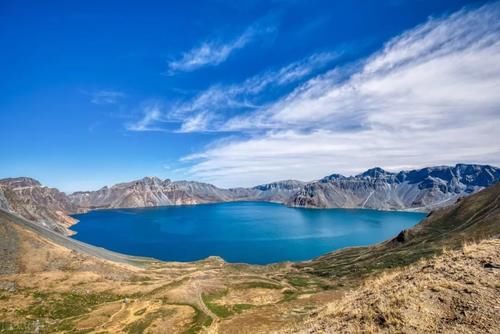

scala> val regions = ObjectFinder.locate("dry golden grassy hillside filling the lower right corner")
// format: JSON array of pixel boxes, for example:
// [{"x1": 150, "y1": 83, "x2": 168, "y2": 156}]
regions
[{"x1": 282, "y1": 239, "x2": 500, "y2": 334}]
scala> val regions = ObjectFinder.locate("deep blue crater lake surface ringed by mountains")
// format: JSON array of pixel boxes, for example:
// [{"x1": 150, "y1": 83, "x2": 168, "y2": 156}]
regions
[{"x1": 71, "y1": 202, "x2": 425, "y2": 264}]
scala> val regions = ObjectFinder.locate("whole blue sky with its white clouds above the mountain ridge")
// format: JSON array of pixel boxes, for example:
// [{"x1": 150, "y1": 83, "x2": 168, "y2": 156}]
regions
[{"x1": 0, "y1": 0, "x2": 500, "y2": 191}]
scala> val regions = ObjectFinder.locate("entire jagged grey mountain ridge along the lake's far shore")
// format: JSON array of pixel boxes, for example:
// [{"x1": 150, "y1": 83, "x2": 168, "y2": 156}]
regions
[{"x1": 69, "y1": 164, "x2": 500, "y2": 211}]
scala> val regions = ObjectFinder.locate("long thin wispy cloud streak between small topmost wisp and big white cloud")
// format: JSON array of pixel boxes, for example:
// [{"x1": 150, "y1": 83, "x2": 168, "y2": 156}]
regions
[{"x1": 126, "y1": 52, "x2": 341, "y2": 133}]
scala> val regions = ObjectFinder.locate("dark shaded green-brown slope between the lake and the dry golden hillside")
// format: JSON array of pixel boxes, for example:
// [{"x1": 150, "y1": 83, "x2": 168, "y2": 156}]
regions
[{"x1": 295, "y1": 183, "x2": 500, "y2": 286}]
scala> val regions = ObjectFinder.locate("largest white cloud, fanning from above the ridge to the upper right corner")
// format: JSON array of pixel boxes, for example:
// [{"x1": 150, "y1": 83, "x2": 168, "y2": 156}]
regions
[{"x1": 184, "y1": 3, "x2": 500, "y2": 186}]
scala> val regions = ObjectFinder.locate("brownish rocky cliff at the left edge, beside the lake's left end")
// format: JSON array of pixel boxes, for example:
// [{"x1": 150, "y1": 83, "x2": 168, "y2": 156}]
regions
[{"x1": 0, "y1": 177, "x2": 78, "y2": 234}]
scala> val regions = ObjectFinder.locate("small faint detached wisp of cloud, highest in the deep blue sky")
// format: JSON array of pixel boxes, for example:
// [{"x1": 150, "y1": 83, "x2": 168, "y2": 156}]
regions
[{"x1": 167, "y1": 25, "x2": 274, "y2": 75}]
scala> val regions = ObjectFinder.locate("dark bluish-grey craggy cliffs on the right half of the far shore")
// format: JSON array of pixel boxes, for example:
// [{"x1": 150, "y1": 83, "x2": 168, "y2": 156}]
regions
[{"x1": 287, "y1": 164, "x2": 500, "y2": 210}]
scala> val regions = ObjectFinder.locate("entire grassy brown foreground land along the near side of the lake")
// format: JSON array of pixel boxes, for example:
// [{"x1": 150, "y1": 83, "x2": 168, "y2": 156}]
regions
[{"x1": 0, "y1": 179, "x2": 500, "y2": 333}]
